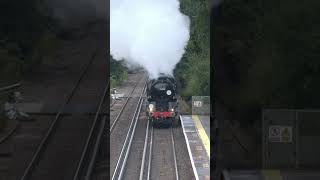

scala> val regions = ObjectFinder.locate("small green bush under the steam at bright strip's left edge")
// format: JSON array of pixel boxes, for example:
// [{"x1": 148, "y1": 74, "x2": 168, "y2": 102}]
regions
[{"x1": 110, "y1": 56, "x2": 128, "y2": 88}]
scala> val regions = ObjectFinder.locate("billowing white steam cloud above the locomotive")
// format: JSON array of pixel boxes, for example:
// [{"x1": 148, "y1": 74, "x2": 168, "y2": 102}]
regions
[{"x1": 110, "y1": 0, "x2": 190, "y2": 78}]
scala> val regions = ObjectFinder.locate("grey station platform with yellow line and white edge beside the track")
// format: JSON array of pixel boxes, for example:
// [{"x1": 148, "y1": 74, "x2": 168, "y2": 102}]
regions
[{"x1": 180, "y1": 115, "x2": 210, "y2": 180}]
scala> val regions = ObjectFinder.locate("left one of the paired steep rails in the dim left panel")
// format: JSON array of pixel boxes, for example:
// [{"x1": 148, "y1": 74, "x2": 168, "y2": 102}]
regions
[{"x1": 73, "y1": 81, "x2": 110, "y2": 180}]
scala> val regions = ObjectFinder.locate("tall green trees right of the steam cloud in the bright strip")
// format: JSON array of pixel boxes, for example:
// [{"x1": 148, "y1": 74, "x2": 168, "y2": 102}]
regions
[{"x1": 174, "y1": 0, "x2": 210, "y2": 99}]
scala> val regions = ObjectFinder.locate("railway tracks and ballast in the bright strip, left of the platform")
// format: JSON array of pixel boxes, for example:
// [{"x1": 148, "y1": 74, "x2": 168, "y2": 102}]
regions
[{"x1": 110, "y1": 72, "x2": 194, "y2": 180}]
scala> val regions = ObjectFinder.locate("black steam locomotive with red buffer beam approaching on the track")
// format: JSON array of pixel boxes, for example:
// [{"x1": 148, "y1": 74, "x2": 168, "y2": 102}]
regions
[{"x1": 146, "y1": 74, "x2": 180, "y2": 126}]
